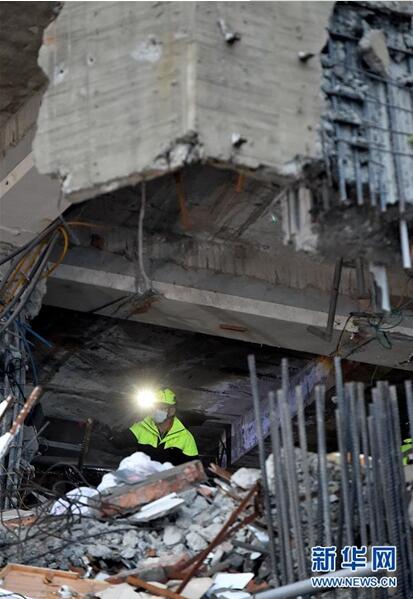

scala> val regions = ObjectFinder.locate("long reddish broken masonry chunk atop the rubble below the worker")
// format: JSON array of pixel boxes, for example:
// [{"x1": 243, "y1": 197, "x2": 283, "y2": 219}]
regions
[{"x1": 101, "y1": 460, "x2": 206, "y2": 516}]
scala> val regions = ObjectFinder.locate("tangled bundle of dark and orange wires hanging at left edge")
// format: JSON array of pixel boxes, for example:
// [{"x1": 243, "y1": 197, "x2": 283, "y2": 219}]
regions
[{"x1": 0, "y1": 218, "x2": 97, "y2": 335}]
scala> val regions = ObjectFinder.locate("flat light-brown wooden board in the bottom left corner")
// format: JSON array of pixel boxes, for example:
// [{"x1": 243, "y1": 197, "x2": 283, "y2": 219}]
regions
[{"x1": 0, "y1": 564, "x2": 109, "y2": 599}]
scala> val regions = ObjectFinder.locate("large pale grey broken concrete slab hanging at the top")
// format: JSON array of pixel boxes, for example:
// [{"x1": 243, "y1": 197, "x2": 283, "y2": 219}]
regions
[{"x1": 34, "y1": 2, "x2": 333, "y2": 201}]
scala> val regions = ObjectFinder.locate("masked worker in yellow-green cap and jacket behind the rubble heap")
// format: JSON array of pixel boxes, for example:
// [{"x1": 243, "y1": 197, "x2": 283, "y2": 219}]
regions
[{"x1": 111, "y1": 389, "x2": 198, "y2": 466}]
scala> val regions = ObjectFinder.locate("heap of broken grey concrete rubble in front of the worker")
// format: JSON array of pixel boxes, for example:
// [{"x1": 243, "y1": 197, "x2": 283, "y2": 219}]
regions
[{"x1": 0, "y1": 450, "x2": 354, "y2": 599}]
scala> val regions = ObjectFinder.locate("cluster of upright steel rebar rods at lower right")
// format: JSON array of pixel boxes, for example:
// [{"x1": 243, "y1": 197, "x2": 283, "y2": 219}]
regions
[{"x1": 248, "y1": 356, "x2": 413, "y2": 599}]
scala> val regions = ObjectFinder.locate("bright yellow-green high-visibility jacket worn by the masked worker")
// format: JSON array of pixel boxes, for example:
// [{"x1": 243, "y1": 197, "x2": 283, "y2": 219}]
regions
[{"x1": 129, "y1": 416, "x2": 198, "y2": 456}]
